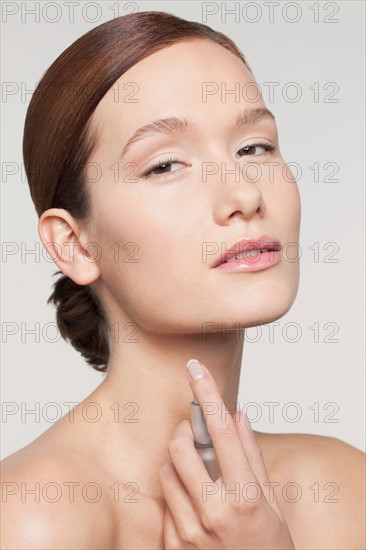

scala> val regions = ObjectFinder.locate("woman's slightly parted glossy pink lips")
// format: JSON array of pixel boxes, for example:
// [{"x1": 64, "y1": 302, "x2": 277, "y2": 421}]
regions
[{"x1": 212, "y1": 235, "x2": 282, "y2": 268}]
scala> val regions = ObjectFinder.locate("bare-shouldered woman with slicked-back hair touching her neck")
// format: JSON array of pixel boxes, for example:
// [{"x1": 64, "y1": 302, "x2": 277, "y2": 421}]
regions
[{"x1": 2, "y1": 12, "x2": 364, "y2": 549}]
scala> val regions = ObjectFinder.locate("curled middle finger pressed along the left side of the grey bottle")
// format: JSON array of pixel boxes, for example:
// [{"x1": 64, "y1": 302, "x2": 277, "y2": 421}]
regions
[{"x1": 168, "y1": 419, "x2": 217, "y2": 508}]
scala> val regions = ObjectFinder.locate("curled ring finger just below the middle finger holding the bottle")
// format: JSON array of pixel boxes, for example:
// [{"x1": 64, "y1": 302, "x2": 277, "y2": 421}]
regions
[{"x1": 159, "y1": 463, "x2": 200, "y2": 540}]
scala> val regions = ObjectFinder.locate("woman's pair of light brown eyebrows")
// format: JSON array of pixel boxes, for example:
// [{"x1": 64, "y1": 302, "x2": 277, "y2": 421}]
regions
[{"x1": 120, "y1": 108, "x2": 275, "y2": 159}]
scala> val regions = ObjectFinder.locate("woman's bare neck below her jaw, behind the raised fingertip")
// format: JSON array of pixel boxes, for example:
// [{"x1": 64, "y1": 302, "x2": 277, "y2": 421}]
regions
[{"x1": 93, "y1": 331, "x2": 244, "y2": 499}]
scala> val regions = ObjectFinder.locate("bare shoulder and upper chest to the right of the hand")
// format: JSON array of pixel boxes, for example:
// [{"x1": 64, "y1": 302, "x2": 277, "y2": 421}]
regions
[{"x1": 256, "y1": 432, "x2": 366, "y2": 550}]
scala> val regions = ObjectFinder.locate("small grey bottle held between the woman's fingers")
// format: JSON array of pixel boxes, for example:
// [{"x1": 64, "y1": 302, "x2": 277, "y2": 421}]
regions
[{"x1": 191, "y1": 399, "x2": 221, "y2": 481}]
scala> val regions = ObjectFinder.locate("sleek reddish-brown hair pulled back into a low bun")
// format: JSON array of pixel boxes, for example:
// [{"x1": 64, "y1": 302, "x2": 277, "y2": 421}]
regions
[{"x1": 23, "y1": 11, "x2": 250, "y2": 372}]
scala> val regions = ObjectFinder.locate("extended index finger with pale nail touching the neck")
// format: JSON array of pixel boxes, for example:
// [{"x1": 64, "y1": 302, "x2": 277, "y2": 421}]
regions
[{"x1": 187, "y1": 360, "x2": 256, "y2": 486}]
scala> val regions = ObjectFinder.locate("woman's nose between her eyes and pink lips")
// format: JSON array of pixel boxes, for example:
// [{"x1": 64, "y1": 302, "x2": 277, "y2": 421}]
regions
[{"x1": 213, "y1": 161, "x2": 266, "y2": 225}]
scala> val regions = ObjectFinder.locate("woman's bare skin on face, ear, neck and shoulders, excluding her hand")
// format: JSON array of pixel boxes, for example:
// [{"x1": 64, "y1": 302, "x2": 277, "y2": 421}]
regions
[{"x1": 2, "y1": 40, "x2": 365, "y2": 550}]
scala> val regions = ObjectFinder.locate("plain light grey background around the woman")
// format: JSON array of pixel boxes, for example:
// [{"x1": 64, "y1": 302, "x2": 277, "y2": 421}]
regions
[{"x1": 1, "y1": 1, "x2": 366, "y2": 457}]
